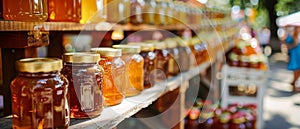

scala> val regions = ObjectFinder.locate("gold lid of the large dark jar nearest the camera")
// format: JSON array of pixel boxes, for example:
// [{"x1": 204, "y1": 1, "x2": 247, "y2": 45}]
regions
[{"x1": 16, "y1": 58, "x2": 62, "y2": 73}]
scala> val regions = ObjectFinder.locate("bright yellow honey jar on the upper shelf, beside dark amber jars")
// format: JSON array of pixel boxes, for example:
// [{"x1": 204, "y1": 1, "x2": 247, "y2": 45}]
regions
[{"x1": 80, "y1": 0, "x2": 107, "y2": 24}]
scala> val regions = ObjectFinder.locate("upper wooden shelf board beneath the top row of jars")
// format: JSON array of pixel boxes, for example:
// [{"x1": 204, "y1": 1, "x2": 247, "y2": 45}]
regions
[{"x1": 0, "y1": 19, "x2": 235, "y2": 31}]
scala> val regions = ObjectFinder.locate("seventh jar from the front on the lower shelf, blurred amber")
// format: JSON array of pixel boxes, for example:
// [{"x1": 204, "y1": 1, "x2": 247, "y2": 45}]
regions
[{"x1": 164, "y1": 38, "x2": 180, "y2": 78}]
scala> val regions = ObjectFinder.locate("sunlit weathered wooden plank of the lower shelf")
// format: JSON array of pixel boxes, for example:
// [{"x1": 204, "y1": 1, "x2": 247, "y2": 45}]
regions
[{"x1": 0, "y1": 62, "x2": 210, "y2": 129}]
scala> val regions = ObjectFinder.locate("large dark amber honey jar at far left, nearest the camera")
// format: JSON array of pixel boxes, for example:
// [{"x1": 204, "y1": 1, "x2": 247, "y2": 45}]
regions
[{"x1": 10, "y1": 58, "x2": 70, "y2": 129}]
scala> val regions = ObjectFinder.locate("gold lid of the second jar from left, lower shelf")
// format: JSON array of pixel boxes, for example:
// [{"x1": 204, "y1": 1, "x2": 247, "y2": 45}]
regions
[{"x1": 63, "y1": 52, "x2": 100, "y2": 63}]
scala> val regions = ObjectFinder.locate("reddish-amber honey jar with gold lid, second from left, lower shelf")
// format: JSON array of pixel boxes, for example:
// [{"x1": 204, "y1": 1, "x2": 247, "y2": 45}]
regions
[{"x1": 61, "y1": 53, "x2": 103, "y2": 118}]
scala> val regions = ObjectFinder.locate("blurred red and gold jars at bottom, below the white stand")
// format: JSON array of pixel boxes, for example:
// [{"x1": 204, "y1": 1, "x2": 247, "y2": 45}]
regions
[{"x1": 185, "y1": 103, "x2": 257, "y2": 129}]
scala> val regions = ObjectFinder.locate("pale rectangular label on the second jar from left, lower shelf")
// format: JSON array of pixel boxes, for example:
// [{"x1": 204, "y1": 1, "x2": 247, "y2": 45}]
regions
[{"x1": 80, "y1": 75, "x2": 95, "y2": 111}]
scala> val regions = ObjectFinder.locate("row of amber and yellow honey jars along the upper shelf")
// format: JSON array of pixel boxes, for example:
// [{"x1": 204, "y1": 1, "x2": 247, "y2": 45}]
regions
[{"x1": 1, "y1": 0, "x2": 229, "y2": 25}]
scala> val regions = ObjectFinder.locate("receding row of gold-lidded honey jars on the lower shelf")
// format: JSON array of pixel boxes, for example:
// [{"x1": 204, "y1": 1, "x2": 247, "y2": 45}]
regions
[{"x1": 11, "y1": 38, "x2": 209, "y2": 128}]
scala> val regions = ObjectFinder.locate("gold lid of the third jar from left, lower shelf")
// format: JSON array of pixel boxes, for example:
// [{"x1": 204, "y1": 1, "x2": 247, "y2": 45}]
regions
[{"x1": 91, "y1": 47, "x2": 122, "y2": 57}]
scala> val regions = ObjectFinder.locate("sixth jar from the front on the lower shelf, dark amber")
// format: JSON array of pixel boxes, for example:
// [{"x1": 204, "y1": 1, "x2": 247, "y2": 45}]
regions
[{"x1": 153, "y1": 42, "x2": 171, "y2": 83}]
